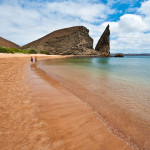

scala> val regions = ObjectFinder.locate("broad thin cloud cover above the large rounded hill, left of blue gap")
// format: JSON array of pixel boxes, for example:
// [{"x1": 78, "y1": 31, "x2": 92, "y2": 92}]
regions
[{"x1": 0, "y1": 0, "x2": 114, "y2": 45}]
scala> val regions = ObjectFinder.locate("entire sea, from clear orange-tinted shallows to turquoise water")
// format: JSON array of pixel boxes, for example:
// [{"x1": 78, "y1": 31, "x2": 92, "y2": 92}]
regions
[{"x1": 39, "y1": 56, "x2": 150, "y2": 149}]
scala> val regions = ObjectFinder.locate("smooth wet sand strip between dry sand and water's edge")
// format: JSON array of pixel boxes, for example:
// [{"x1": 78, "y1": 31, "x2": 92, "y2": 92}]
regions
[{"x1": 29, "y1": 65, "x2": 131, "y2": 150}]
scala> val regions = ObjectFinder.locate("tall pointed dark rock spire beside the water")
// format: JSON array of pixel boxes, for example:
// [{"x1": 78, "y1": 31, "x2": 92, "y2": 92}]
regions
[{"x1": 95, "y1": 25, "x2": 110, "y2": 56}]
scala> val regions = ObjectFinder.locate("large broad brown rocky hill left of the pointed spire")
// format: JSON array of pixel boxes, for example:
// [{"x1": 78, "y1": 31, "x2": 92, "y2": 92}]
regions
[{"x1": 22, "y1": 26, "x2": 96, "y2": 55}]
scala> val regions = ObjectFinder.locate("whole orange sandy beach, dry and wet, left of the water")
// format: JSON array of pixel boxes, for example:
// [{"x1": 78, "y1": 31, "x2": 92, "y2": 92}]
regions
[{"x1": 0, "y1": 54, "x2": 132, "y2": 150}]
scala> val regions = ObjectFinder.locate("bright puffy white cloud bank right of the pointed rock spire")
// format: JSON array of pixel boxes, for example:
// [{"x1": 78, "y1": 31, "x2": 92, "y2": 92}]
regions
[{"x1": 94, "y1": 0, "x2": 150, "y2": 53}]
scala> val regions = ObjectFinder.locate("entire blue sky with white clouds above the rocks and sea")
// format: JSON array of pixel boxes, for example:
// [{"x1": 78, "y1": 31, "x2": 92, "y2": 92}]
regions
[{"x1": 0, "y1": 0, "x2": 150, "y2": 53}]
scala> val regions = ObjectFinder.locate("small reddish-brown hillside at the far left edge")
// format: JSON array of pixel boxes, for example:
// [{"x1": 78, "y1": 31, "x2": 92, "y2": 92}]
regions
[{"x1": 0, "y1": 37, "x2": 20, "y2": 49}]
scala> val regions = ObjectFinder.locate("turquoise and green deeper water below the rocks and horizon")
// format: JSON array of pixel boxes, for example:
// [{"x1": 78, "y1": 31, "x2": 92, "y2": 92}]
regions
[{"x1": 44, "y1": 56, "x2": 150, "y2": 87}]
